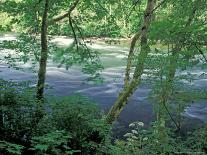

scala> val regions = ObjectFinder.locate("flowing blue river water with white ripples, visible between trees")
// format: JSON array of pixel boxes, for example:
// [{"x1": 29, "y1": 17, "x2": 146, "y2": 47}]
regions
[{"x1": 0, "y1": 36, "x2": 207, "y2": 137}]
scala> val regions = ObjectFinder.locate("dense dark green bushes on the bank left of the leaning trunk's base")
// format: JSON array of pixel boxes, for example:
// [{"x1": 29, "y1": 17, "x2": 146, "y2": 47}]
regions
[{"x1": 0, "y1": 80, "x2": 111, "y2": 154}]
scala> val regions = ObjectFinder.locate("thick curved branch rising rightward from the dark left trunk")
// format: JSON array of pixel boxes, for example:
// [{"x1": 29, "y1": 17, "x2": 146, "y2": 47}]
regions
[{"x1": 48, "y1": 0, "x2": 80, "y2": 25}]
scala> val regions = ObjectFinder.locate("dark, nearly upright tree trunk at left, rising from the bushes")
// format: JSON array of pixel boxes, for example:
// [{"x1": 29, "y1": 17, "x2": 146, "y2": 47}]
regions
[{"x1": 36, "y1": 0, "x2": 49, "y2": 100}]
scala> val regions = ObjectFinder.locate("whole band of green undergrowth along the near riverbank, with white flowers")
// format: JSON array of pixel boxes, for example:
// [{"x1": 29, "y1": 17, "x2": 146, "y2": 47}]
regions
[{"x1": 0, "y1": 77, "x2": 207, "y2": 155}]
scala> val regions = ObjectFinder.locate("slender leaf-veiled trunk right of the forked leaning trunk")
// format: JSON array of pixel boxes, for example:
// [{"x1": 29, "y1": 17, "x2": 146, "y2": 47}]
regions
[{"x1": 157, "y1": 2, "x2": 199, "y2": 143}]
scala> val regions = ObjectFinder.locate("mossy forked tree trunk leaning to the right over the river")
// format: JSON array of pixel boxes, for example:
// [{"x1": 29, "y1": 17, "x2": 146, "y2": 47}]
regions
[{"x1": 107, "y1": 0, "x2": 155, "y2": 124}]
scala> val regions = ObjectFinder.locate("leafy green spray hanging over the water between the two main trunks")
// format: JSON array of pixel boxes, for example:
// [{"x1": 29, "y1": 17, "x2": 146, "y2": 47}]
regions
[{"x1": 51, "y1": 41, "x2": 103, "y2": 83}]
